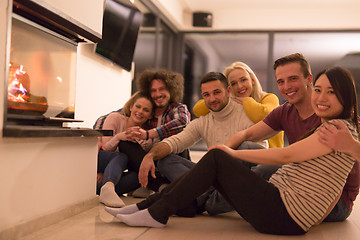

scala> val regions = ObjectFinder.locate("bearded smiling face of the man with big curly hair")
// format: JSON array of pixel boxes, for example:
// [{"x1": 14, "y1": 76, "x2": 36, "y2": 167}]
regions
[{"x1": 150, "y1": 79, "x2": 170, "y2": 108}]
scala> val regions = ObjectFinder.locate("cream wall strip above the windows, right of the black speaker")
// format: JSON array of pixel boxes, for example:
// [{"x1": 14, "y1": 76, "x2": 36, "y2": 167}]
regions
[{"x1": 213, "y1": 7, "x2": 360, "y2": 30}]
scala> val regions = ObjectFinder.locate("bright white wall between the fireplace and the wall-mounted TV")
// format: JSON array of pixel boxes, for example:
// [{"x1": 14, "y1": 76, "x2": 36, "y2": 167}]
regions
[{"x1": 72, "y1": 43, "x2": 132, "y2": 128}]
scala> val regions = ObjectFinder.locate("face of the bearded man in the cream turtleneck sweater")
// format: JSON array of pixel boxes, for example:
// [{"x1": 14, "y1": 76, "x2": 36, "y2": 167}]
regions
[{"x1": 201, "y1": 80, "x2": 229, "y2": 112}]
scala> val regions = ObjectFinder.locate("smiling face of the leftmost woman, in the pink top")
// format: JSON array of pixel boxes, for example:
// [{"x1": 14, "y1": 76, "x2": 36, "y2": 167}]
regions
[{"x1": 130, "y1": 97, "x2": 153, "y2": 126}]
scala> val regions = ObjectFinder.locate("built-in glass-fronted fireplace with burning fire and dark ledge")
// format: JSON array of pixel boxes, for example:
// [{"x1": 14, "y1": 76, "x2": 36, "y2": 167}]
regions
[{"x1": 3, "y1": 0, "x2": 108, "y2": 137}]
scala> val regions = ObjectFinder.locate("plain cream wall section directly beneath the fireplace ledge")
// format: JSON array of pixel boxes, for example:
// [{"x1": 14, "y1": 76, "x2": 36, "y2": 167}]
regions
[{"x1": 0, "y1": 137, "x2": 97, "y2": 232}]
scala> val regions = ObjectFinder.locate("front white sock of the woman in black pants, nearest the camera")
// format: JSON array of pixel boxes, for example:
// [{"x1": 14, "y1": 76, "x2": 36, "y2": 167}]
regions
[{"x1": 116, "y1": 208, "x2": 165, "y2": 228}]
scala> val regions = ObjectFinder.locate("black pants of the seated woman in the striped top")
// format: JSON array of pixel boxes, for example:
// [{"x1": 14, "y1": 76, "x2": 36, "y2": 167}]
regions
[{"x1": 138, "y1": 149, "x2": 305, "y2": 235}]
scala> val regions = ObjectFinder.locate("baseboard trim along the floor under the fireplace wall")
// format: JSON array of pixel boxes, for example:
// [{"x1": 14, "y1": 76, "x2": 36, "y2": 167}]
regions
[{"x1": 0, "y1": 196, "x2": 99, "y2": 240}]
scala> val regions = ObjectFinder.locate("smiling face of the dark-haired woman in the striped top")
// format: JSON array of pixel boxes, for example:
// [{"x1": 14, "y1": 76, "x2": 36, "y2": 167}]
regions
[{"x1": 311, "y1": 74, "x2": 343, "y2": 122}]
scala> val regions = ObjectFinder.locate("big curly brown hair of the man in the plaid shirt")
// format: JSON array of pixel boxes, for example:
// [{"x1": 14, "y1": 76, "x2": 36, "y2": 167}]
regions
[{"x1": 136, "y1": 69, "x2": 184, "y2": 103}]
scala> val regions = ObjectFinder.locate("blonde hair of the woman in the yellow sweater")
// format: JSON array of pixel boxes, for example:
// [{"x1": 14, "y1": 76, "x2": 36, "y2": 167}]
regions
[{"x1": 224, "y1": 62, "x2": 266, "y2": 102}]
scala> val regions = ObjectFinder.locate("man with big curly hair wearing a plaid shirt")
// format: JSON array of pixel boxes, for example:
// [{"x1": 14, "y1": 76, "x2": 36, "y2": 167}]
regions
[{"x1": 119, "y1": 69, "x2": 191, "y2": 197}]
